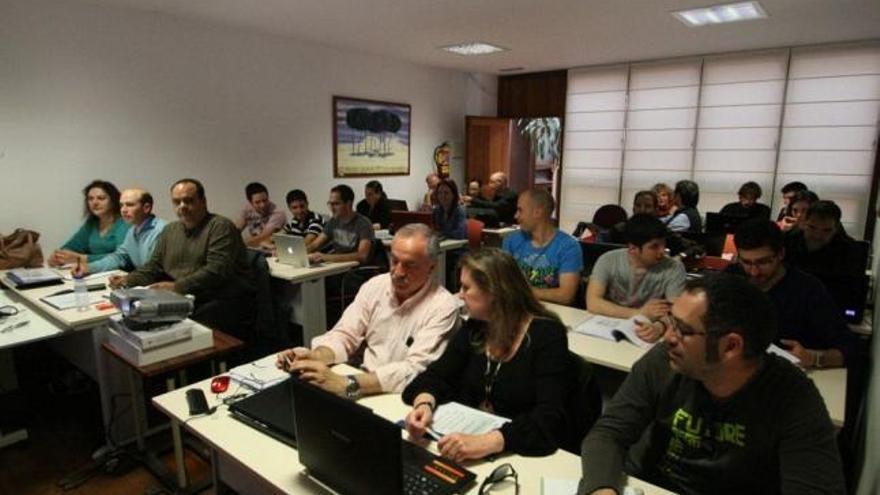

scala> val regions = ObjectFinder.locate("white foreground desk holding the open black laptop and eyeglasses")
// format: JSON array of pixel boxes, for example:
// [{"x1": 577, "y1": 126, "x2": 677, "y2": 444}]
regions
[{"x1": 153, "y1": 360, "x2": 669, "y2": 494}]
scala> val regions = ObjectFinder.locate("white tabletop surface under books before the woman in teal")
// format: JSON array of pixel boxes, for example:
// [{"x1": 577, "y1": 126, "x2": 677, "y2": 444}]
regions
[{"x1": 0, "y1": 270, "x2": 119, "y2": 329}]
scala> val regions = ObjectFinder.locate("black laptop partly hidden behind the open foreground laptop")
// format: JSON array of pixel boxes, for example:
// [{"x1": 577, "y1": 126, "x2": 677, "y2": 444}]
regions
[{"x1": 229, "y1": 380, "x2": 296, "y2": 447}]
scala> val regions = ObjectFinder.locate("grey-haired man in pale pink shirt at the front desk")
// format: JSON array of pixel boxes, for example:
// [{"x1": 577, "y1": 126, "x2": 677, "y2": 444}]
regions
[{"x1": 278, "y1": 224, "x2": 458, "y2": 399}]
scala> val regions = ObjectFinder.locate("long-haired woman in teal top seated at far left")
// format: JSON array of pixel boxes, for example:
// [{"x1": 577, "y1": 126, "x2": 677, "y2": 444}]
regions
[{"x1": 48, "y1": 180, "x2": 129, "y2": 266}]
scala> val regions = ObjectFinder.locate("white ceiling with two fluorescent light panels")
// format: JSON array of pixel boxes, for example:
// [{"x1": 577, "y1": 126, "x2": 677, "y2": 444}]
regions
[{"x1": 91, "y1": 0, "x2": 880, "y2": 74}]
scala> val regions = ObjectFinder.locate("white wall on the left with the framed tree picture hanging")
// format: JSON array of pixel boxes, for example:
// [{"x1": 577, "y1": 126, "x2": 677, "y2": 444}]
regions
[{"x1": 0, "y1": 0, "x2": 497, "y2": 251}]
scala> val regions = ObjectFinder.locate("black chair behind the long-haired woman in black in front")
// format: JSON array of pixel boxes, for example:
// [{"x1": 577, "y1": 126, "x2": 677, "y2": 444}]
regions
[{"x1": 559, "y1": 351, "x2": 602, "y2": 455}]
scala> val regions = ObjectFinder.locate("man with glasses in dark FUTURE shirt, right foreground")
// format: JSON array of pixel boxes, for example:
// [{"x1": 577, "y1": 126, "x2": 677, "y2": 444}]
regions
[{"x1": 577, "y1": 274, "x2": 845, "y2": 495}]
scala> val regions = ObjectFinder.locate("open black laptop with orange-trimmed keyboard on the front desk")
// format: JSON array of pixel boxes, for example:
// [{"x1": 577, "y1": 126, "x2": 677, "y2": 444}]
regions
[{"x1": 290, "y1": 379, "x2": 476, "y2": 495}]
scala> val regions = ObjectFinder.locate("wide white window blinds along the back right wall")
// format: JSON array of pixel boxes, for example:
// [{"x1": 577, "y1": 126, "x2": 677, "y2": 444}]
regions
[{"x1": 560, "y1": 43, "x2": 880, "y2": 237}]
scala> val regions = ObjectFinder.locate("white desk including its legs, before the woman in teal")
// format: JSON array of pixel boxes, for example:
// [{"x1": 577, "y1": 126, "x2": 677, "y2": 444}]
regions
[{"x1": 0, "y1": 271, "x2": 129, "y2": 446}]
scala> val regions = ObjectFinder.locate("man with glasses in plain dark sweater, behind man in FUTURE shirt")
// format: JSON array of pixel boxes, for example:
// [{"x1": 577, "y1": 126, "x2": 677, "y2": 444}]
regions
[{"x1": 728, "y1": 219, "x2": 855, "y2": 368}]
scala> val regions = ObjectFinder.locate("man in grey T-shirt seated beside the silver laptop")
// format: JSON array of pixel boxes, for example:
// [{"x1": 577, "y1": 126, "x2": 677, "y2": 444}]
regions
[{"x1": 309, "y1": 184, "x2": 375, "y2": 265}]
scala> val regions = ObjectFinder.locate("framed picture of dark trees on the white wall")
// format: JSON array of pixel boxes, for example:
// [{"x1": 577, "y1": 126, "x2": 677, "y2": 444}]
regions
[{"x1": 333, "y1": 96, "x2": 411, "y2": 177}]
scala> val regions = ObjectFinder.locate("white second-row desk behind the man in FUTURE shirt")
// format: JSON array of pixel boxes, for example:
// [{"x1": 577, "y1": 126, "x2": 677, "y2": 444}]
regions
[{"x1": 544, "y1": 303, "x2": 846, "y2": 428}]
